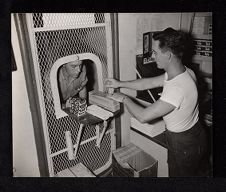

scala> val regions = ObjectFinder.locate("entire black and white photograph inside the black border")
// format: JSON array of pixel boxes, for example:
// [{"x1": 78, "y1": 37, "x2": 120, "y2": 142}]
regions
[{"x1": 11, "y1": 11, "x2": 214, "y2": 179}]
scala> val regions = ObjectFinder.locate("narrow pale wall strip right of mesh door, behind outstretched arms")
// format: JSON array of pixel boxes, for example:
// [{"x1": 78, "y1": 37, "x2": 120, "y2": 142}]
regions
[{"x1": 118, "y1": 13, "x2": 136, "y2": 146}]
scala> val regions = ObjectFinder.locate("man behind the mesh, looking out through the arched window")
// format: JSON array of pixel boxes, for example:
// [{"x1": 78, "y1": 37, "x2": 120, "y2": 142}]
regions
[{"x1": 58, "y1": 60, "x2": 88, "y2": 107}]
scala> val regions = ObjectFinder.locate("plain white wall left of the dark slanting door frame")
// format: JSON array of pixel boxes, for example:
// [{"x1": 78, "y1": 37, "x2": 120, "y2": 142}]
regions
[{"x1": 11, "y1": 17, "x2": 40, "y2": 177}]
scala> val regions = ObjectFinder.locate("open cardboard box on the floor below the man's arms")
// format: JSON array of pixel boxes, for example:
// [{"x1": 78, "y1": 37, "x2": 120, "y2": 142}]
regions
[{"x1": 112, "y1": 143, "x2": 158, "y2": 177}]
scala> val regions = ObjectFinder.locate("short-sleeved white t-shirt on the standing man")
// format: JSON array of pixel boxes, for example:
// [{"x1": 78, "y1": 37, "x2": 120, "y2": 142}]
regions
[{"x1": 160, "y1": 67, "x2": 199, "y2": 132}]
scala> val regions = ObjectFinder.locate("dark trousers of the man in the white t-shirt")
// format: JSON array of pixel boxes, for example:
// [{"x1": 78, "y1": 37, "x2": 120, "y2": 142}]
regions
[{"x1": 166, "y1": 122, "x2": 208, "y2": 177}]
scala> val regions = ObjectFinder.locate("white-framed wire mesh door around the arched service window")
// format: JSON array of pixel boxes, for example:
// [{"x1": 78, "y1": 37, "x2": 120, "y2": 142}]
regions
[{"x1": 26, "y1": 13, "x2": 115, "y2": 176}]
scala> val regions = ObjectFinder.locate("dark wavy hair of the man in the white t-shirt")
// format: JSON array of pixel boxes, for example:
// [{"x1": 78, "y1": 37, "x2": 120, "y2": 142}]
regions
[{"x1": 153, "y1": 28, "x2": 185, "y2": 58}]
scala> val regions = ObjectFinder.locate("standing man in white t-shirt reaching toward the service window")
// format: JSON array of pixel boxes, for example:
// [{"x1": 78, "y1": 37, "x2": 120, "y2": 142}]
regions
[{"x1": 106, "y1": 28, "x2": 206, "y2": 177}]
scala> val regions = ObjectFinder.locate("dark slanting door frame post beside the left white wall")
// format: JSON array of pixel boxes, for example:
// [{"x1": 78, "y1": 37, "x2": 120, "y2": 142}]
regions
[{"x1": 13, "y1": 13, "x2": 49, "y2": 177}]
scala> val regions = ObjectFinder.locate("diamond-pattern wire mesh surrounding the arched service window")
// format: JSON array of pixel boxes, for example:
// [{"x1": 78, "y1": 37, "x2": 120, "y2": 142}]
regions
[{"x1": 32, "y1": 13, "x2": 112, "y2": 174}]
